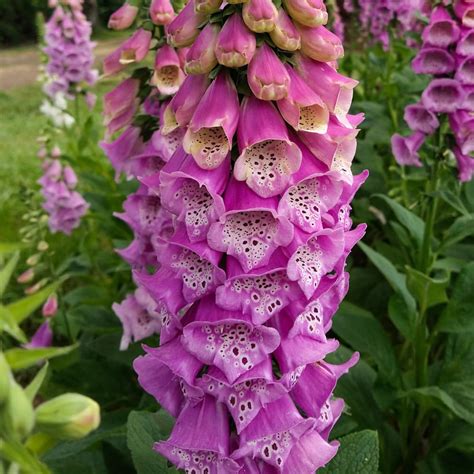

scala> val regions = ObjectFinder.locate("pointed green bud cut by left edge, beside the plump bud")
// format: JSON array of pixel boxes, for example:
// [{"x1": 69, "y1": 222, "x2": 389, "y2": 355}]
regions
[{"x1": 0, "y1": 377, "x2": 35, "y2": 439}]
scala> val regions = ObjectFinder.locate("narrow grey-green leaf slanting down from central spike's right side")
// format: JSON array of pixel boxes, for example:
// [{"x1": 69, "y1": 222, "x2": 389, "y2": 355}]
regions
[{"x1": 358, "y1": 242, "x2": 416, "y2": 324}]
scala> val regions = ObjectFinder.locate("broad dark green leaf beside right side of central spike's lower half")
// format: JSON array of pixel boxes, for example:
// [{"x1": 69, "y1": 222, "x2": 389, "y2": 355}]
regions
[{"x1": 332, "y1": 303, "x2": 399, "y2": 381}]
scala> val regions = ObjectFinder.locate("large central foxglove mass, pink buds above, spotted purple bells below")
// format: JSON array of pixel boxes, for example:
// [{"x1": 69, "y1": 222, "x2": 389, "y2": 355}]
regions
[{"x1": 102, "y1": 0, "x2": 367, "y2": 474}]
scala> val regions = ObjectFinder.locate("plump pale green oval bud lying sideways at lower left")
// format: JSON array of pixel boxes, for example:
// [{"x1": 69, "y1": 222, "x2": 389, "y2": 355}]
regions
[{"x1": 36, "y1": 393, "x2": 100, "y2": 439}]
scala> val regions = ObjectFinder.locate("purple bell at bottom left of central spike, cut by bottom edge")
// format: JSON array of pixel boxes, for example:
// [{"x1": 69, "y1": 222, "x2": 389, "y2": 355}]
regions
[{"x1": 154, "y1": 396, "x2": 240, "y2": 474}]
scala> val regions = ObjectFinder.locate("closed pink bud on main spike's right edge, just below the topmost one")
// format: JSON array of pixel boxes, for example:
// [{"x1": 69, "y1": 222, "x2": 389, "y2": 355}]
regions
[{"x1": 297, "y1": 25, "x2": 344, "y2": 62}]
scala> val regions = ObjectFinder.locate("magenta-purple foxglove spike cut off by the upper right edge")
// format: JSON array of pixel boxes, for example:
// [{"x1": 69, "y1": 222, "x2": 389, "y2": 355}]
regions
[{"x1": 392, "y1": 0, "x2": 474, "y2": 181}]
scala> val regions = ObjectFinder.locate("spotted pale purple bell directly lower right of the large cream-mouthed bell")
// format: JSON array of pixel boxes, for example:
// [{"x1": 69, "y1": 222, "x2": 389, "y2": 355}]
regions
[{"x1": 278, "y1": 176, "x2": 343, "y2": 234}]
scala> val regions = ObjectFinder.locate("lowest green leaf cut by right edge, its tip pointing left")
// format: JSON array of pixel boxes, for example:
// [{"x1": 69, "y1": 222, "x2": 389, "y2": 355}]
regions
[{"x1": 407, "y1": 381, "x2": 474, "y2": 424}]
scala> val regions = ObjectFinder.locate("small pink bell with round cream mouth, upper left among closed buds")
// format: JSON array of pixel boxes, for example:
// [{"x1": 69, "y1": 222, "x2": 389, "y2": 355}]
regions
[{"x1": 151, "y1": 44, "x2": 184, "y2": 95}]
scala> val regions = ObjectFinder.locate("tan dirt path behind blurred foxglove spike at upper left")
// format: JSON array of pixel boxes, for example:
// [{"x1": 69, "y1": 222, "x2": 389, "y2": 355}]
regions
[{"x1": 0, "y1": 39, "x2": 120, "y2": 91}]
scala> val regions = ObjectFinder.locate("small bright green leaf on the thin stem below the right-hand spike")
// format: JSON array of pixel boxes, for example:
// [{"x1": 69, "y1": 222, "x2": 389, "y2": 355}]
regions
[{"x1": 405, "y1": 266, "x2": 449, "y2": 309}]
